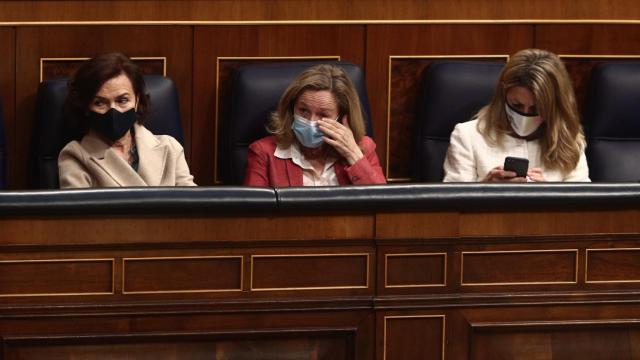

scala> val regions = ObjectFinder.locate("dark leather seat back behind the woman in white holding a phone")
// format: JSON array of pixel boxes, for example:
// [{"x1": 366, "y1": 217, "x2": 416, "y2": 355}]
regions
[{"x1": 413, "y1": 61, "x2": 504, "y2": 182}]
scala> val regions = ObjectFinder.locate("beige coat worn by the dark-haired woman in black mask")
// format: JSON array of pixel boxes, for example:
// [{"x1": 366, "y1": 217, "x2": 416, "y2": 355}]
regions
[{"x1": 58, "y1": 124, "x2": 196, "y2": 189}]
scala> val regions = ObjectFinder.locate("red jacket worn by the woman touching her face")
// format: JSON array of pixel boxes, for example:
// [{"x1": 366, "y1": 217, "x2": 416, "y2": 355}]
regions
[{"x1": 244, "y1": 136, "x2": 386, "y2": 187}]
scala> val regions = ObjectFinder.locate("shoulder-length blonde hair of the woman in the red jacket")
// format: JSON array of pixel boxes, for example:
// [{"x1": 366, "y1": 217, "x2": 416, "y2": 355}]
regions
[{"x1": 267, "y1": 64, "x2": 365, "y2": 147}]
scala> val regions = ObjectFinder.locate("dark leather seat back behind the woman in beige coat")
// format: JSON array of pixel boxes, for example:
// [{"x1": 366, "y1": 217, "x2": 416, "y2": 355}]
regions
[{"x1": 33, "y1": 75, "x2": 184, "y2": 189}]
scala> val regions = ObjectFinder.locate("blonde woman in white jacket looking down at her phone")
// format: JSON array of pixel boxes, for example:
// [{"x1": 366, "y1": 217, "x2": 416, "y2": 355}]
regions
[{"x1": 444, "y1": 49, "x2": 590, "y2": 182}]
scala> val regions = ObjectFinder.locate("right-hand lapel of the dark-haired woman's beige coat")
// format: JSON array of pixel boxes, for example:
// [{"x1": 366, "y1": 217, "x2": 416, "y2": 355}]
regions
[{"x1": 135, "y1": 124, "x2": 168, "y2": 186}]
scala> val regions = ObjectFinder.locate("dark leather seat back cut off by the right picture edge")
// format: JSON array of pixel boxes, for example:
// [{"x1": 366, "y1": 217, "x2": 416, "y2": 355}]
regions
[{"x1": 585, "y1": 62, "x2": 640, "y2": 182}]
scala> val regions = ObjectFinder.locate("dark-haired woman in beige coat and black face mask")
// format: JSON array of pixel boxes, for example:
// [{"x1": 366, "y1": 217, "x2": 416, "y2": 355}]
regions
[{"x1": 58, "y1": 53, "x2": 195, "y2": 188}]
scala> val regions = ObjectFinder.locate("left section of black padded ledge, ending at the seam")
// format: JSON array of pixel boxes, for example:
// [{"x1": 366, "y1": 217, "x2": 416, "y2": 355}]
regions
[{"x1": 0, "y1": 186, "x2": 278, "y2": 216}]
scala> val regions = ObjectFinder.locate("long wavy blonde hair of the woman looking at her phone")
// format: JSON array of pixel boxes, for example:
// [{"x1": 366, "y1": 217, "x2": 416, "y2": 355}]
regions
[{"x1": 476, "y1": 49, "x2": 585, "y2": 174}]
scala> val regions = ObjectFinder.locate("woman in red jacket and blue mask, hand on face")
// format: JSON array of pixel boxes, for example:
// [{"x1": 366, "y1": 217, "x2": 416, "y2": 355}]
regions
[{"x1": 244, "y1": 64, "x2": 386, "y2": 187}]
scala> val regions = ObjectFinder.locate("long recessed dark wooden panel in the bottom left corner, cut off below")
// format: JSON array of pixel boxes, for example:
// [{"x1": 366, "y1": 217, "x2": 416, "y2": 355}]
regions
[{"x1": 3, "y1": 330, "x2": 355, "y2": 360}]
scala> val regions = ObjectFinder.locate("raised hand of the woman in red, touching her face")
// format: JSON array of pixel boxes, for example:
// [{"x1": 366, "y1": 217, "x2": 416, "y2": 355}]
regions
[{"x1": 318, "y1": 115, "x2": 364, "y2": 165}]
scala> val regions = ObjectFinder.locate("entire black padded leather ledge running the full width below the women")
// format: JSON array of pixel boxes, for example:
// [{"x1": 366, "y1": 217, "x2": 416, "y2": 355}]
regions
[{"x1": 0, "y1": 183, "x2": 640, "y2": 215}]
